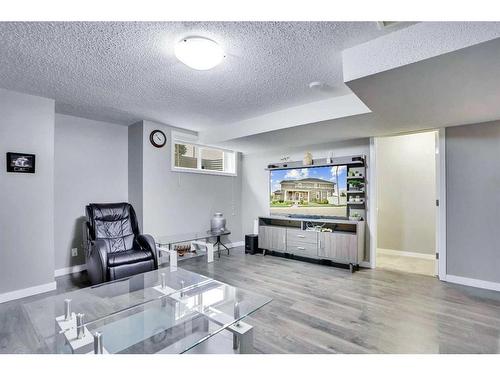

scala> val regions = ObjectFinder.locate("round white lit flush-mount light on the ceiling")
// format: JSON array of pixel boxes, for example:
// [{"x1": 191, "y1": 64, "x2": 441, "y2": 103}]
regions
[{"x1": 175, "y1": 36, "x2": 224, "y2": 70}]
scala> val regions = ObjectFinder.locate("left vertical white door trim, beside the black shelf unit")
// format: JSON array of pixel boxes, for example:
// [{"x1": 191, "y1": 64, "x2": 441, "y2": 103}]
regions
[{"x1": 367, "y1": 137, "x2": 378, "y2": 268}]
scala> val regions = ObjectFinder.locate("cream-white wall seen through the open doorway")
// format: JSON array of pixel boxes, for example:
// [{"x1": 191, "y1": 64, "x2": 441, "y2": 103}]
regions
[{"x1": 376, "y1": 132, "x2": 436, "y2": 254}]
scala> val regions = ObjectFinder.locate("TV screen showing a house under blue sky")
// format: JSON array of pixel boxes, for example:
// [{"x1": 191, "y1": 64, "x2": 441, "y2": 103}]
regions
[{"x1": 269, "y1": 165, "x2": 347, "y2": 217}]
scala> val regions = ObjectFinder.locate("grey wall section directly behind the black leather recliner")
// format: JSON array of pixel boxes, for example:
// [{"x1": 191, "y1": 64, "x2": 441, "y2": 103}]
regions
[{"x1": 54, "y1": 114, "x2": 128, "y2": 269}]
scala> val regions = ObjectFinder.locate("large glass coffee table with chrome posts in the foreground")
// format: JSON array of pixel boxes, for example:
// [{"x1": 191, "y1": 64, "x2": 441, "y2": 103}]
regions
[{"x1": 23, "y1": 267, "x2": 271, "y2": 354}]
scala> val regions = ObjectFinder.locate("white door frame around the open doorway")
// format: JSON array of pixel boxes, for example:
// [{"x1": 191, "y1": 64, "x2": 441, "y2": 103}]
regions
[{"x1": 367, "y1": 128, "x2": 446, "y2": 281}]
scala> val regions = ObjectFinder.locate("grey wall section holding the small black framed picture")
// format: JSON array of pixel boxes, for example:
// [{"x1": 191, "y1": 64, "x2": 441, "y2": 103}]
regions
[{"x1": 0, "y1": 89, "x2": 54, "y2": 293}]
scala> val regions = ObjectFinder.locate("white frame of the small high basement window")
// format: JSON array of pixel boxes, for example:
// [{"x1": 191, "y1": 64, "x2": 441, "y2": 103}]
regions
[{"x1": 170, "y1": 136, "x2": 238, "y2": 177}]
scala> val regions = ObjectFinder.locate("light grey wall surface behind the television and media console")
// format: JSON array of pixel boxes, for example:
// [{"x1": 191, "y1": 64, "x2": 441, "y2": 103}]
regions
[{"x1": 241, "y1": 138, "x2": 370, "y2": 260}]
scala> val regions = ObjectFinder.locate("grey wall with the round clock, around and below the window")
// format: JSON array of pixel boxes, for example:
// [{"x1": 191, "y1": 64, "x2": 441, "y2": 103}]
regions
[{"x1": 129, "y1": 121, "x2": 243, "y2": 242}]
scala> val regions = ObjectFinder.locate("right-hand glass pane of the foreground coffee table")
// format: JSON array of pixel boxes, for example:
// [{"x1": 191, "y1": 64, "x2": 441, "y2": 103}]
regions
[{"x1": 80, "y1": 280, "x2": 271, "y2": 354}]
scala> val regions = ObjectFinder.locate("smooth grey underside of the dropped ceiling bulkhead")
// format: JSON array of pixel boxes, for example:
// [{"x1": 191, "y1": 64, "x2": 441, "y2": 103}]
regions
[{"x1": 221, "y1": 38, "x2": 500, "y2": 153}]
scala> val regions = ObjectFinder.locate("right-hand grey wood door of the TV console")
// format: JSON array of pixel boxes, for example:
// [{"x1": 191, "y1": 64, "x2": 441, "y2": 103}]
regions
[{"x1": 318, "y1": 232, "x2": 358, "y2": 264}]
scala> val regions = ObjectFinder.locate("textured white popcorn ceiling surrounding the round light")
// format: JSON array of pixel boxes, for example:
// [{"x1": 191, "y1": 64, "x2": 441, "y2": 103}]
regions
[{"x1": 0, "y1": 22, "x2": 395, "y2": 130}]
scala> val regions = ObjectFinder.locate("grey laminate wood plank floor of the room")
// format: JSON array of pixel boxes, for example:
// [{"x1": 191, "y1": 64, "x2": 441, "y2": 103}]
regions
[{"x1": 0, "y1": 248, "x2": 500, "y2": 353}]
